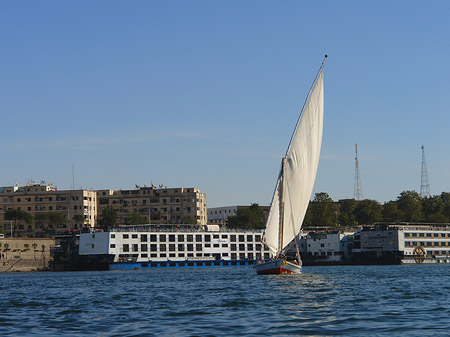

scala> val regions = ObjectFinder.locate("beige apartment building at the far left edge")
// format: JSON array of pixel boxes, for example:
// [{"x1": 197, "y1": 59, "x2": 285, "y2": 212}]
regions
[{"x1": 0, "y1": 182, "x2": 97, "y2": 238}]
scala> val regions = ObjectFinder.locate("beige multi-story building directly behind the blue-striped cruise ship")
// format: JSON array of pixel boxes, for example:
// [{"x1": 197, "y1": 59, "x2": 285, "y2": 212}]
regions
[{"x1": 97, "y1": 186, "x2": 207, "y2": 225}]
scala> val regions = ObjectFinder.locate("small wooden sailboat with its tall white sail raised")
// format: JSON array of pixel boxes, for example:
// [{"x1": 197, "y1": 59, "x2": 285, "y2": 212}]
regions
[{"x1": 253, "y1": 55, "x2": 327, "y2": 274}]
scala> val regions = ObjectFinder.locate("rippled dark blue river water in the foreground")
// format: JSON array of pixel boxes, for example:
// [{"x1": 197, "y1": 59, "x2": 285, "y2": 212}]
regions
[{"x1": 0, "y1": 265, "x2": 450, "y2": 336}]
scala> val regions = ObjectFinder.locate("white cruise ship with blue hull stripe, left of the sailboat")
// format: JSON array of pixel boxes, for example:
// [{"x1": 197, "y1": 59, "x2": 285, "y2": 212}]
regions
[{"x1": 79, "y1": 225, "x2": 268, "y2": 270}]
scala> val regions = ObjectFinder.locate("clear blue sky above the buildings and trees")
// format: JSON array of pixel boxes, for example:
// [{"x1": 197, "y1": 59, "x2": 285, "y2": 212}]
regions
[{"x1": 0, "y1": 0, "x2": 450, "y2": 207}]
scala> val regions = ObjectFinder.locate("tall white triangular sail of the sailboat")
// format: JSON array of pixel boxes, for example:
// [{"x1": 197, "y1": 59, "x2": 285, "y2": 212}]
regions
[{"x1": 264, "y1": 67, "x2": 323, "y2": 255}]
